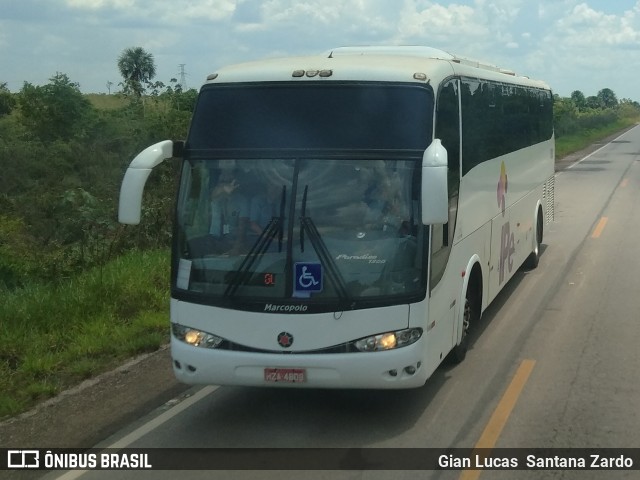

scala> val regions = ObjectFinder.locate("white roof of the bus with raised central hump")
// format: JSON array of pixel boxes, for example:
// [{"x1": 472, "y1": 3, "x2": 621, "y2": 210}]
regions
[{"x1": 206, "y1": 46, "x2": 549, "y2": 90}]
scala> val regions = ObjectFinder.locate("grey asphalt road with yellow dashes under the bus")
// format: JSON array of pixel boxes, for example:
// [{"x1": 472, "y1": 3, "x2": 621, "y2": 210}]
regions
[{"x1": 0, "y1": 127, "x2": 640, "y2": 480}]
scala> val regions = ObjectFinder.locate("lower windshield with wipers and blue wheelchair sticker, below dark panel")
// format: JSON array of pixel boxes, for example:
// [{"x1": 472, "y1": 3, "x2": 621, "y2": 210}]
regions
[{"x1": 174, "y1": 159, "x2": 426, "y2": 310}]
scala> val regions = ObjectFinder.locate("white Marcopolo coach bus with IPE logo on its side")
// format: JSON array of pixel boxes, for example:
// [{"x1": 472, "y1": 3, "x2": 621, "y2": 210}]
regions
[{"x1": 119, "y1": 47, "x2": 555, "y2": 388}]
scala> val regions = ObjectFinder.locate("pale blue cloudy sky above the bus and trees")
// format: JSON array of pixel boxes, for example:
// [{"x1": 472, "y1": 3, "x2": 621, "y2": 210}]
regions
[{"x1": 0, "y1": 0, "x2": 640, "y2": 101}]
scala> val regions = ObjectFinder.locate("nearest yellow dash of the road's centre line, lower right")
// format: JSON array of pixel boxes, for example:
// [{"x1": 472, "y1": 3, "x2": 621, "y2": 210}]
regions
[{"x1": 460, "y1": 360, "x2": 536, "y2": 480}]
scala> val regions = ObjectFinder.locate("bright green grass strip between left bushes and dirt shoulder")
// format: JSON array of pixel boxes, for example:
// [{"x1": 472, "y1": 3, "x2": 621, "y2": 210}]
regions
[{"x1": 0, "y1": 251, "x2": 169, "y2": 418}]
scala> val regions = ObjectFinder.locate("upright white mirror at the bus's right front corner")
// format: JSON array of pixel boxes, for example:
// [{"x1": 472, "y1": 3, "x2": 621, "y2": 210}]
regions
[{"x1": 422, "y1": 138, "x2": 449, "y2": 225}]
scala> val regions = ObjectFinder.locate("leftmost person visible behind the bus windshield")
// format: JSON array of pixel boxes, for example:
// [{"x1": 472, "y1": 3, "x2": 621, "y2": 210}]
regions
[{"x1": 209, "y1": 170, "x2": 249, "y2": 255}]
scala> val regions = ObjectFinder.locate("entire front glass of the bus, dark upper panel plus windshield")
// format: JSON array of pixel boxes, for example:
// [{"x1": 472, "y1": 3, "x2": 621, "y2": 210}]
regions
[{"x1": 173, "y1": 84, "x2": 433, "y2": 312}]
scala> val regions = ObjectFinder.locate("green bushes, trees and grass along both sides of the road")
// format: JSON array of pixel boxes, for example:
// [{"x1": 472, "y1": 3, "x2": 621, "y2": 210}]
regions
[{"x1": 0, "y1": 48, "x2": 640, "y2": 419}]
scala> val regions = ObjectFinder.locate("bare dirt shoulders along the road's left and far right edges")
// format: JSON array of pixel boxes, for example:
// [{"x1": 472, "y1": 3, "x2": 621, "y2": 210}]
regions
[{"x1": 0, "y1": 124, "x2": 636, "y2": 458}]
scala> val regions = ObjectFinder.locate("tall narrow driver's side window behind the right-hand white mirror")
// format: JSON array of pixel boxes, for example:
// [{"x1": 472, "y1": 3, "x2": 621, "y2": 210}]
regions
[{"x1": 431, "y1": 79, "x2": 460, "y2": 288}]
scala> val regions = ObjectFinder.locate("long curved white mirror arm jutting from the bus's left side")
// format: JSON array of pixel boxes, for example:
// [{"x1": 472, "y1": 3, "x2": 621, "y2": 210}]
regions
[{"x1": 118, "y1": 140, "x2": 176, "y2": 225}]
